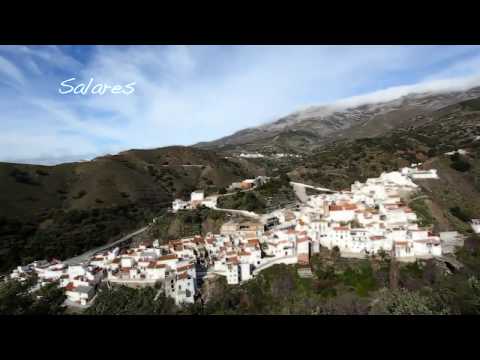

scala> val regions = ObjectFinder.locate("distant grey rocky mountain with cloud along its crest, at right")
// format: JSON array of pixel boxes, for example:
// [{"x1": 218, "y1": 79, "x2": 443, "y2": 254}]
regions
[{"x1": 195, "y1": 87, "x2": 480, "y2": 153}]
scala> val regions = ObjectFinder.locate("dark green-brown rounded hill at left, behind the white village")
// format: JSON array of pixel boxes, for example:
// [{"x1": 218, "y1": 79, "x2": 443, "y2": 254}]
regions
[{"x1": 0, "y1": 146, "x2": 262, "y2": 270}]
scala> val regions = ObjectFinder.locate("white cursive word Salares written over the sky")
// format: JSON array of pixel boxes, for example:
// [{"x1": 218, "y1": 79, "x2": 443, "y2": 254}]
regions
[{"x1": 58, "y1": 78, "x2": 135, "y2": 95}]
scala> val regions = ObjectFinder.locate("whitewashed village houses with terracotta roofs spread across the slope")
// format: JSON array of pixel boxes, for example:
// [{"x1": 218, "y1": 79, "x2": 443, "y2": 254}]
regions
[{"x1": 6, "y1": 164, "x2": 480, "y2": 307}]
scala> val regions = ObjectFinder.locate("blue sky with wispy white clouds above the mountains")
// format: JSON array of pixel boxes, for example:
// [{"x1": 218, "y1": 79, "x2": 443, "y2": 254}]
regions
[{"x1": 0, "y1": 45, "x2": 480, "y2": 164}]
